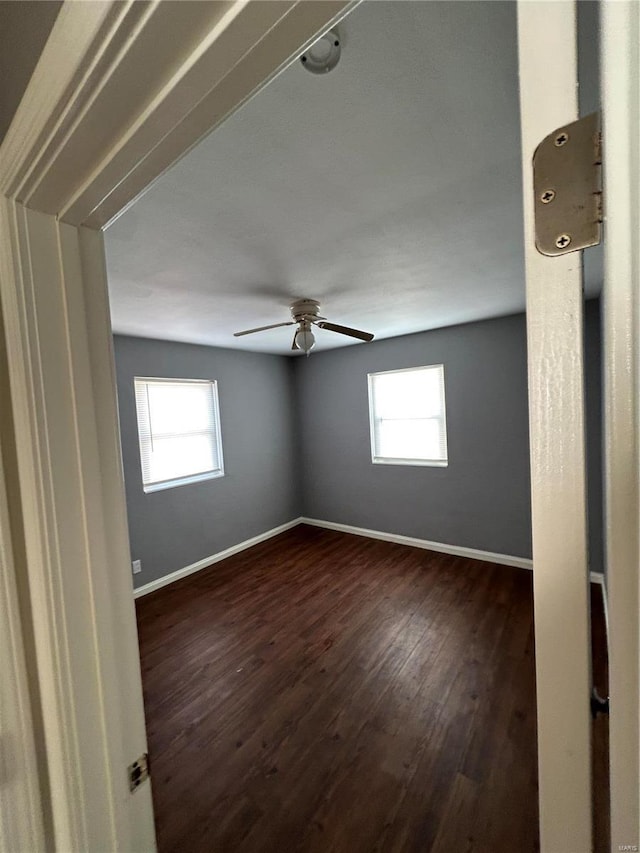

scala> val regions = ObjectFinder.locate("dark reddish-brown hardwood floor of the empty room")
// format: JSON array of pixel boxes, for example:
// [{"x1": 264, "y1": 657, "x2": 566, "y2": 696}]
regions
[{"x1": 137, "y1": 527, "x2": 605, "y2": 853}]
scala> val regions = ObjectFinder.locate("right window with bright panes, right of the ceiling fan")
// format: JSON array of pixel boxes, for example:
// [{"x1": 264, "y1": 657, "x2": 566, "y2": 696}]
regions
[{"x1": 369, "y1": 364, "x2": 447, "y2": 466}]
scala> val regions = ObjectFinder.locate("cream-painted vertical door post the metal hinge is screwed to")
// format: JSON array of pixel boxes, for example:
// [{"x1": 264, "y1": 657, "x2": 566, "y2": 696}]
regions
[{"x1": 518, "y1": 0, "x2": 592, "y2": 853}]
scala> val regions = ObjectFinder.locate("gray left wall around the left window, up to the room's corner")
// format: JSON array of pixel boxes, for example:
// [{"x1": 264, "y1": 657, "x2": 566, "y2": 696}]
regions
[{"x1": 114, "y1": 336, "x2": 300, "y2": 586}]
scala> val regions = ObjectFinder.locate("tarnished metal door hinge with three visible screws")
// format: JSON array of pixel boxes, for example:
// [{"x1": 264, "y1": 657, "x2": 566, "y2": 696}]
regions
[{"x1": 533, "y1": 113, "x2": 602, "y2": 256}]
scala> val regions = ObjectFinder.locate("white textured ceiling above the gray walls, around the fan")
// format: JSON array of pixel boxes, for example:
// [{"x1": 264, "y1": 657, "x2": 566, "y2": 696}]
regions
[{"x1": 106, "y1": 0, "x2": 597, "y2": 354}]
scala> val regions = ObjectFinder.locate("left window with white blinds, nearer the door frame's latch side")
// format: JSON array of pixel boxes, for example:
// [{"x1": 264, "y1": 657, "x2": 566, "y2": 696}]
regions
[{"x1": 134, "y1": 377, "x2": 224, "y2": 492}]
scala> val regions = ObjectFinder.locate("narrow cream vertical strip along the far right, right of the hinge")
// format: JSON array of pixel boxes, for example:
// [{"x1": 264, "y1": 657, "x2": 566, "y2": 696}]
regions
[{"x1": 596, "y1": 2, "x2": 640, "y2": 851}]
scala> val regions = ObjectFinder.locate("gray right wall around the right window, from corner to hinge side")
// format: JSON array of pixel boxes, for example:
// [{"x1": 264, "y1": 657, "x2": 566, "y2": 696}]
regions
[{"x1": 295, "y1": 302, "x2": 601, "y2": 571}]
